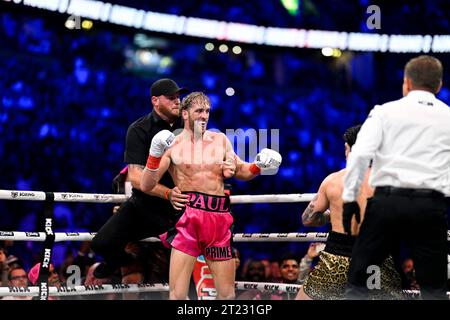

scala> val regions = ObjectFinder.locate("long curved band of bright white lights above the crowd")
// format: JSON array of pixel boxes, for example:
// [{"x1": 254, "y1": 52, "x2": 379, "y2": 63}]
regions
[{"x1": 7, "y1": 0, "x2": 450, "y2": 53}]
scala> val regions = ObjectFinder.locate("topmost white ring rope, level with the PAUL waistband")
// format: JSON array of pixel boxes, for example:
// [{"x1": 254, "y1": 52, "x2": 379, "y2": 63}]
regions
[{"x1": 0, "y1": 190, "x2": 315, "y2": 204}]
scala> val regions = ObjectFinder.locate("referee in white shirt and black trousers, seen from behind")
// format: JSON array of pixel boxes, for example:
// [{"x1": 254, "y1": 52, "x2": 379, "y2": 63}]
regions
[{"x1": 342, "y1": 56, "x2": 450, "y2": 299}]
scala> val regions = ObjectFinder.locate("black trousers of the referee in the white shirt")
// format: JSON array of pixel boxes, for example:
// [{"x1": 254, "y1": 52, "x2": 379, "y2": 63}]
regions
[{"x1": 346, "y1": 188, "x2": 447, "y2": 299}]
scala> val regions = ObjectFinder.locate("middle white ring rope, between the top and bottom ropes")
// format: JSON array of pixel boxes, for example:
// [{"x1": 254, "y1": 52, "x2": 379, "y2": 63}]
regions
[{"x1": 0, "y1": 231, "x2": 338, "y2": 242}]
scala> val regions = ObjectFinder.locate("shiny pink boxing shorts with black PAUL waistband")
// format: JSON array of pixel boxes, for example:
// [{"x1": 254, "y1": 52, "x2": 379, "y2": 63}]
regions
[{"x1": 160, "y1": 191, "x2": 234, "y2": 260}]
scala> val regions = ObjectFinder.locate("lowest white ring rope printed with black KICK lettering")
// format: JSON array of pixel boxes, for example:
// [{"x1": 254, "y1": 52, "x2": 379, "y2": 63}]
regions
[{"x1": 0, "y1": 281, "x2": 450, "y2": 297}]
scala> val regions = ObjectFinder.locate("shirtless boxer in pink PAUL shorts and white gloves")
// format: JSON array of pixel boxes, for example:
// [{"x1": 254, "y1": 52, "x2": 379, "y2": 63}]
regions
[{"x1": 141, "y1": 92, "x2": 281, "y2": 299}]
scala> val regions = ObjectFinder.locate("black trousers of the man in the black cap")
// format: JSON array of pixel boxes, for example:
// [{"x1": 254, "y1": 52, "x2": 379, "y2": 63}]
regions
[{"x1": 92, "y1": 192, "x2": 174, "y2": 267}]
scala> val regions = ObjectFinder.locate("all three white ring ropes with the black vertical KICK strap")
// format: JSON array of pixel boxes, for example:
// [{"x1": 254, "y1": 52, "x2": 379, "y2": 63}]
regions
[{"x1": 0, "y1": 190, "x2": 450, "y2": 300}]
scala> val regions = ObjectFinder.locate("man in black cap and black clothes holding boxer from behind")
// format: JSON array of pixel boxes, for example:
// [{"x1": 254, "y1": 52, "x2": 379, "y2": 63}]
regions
[{"x1": 92, "y1": 79, "x2": 187, "y2": 278}]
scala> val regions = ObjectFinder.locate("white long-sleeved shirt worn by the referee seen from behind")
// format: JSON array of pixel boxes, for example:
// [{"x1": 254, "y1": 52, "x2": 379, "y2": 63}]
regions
[{"x1": 342, "y1": 90, "x2": 450, "y2": 202}]
